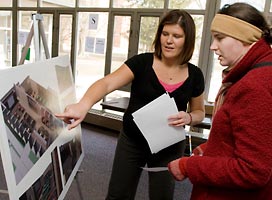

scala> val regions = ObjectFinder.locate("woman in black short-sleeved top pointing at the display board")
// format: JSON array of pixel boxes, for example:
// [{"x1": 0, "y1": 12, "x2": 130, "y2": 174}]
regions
[{"x1": 56, "y1": 10, "x2": 205, "y2": 200}]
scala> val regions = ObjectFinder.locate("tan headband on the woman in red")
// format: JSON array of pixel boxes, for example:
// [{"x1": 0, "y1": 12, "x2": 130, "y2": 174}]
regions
[{"x1": 211, "y1": 14, "x2": 262, "y2": 44}]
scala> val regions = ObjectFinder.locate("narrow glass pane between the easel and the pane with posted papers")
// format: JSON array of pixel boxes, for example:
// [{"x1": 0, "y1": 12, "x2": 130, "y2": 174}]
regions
[{"x1": 59, "y1": 14, "x2": 73, "y2": 56}]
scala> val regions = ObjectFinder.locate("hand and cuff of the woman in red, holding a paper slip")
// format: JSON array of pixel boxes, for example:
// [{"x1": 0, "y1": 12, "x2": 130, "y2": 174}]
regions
[{"x1": 168, "y1": 157, "x2": 188, "y2": 181}]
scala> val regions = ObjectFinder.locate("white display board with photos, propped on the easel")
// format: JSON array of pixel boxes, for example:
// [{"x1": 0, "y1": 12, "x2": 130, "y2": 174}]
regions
[{"x1": 0, "y1": 56, "x2": 84, "y2": 200}]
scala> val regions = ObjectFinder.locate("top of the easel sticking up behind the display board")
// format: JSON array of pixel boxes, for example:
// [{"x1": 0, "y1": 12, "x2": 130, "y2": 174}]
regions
[{"x1": 19, "y1": 13, "x2": 50, "y2": 65}]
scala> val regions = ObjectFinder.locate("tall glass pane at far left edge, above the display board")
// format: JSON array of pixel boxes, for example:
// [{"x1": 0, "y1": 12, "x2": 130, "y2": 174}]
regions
[{"x1": 0, "y1": 11, "x2": 12, "y2": 69}]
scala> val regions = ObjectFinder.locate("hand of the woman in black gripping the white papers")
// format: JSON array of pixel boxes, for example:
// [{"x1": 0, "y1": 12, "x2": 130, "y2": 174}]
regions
[{"x1": 168, "y1": 111, "x2": 192, "y2": 126}]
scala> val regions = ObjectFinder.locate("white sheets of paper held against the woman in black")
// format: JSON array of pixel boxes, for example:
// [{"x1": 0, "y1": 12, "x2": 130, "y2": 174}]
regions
[{"x1": 132, "y1": 93, "x2": 185, "y2": 153}]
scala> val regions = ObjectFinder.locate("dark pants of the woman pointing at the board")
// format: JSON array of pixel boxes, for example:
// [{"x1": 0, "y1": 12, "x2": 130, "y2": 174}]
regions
[{"x1": 106, "y1": 131, "x2": 185, "y2": 200}]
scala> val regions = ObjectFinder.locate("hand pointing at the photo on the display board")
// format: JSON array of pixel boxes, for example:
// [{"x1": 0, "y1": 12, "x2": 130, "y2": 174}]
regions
[{"x1": 55, "y1": 103, "x2": 88, "y2": 130}]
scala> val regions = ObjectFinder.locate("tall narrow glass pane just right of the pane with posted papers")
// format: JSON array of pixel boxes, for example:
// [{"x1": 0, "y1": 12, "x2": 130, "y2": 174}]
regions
[{"x1": 111, "y1": 16, "x2": 131, "y2": 72}]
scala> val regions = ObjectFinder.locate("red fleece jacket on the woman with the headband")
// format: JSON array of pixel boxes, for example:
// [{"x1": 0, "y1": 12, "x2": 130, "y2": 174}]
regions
[{"x1": 185, "y1": 39, "x2": 272, "y2": 200}]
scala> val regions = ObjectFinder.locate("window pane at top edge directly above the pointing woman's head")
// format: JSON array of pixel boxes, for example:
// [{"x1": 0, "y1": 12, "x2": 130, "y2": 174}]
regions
[{"x1": 169, "y1": 0, "x2": 206, "y2": 10}]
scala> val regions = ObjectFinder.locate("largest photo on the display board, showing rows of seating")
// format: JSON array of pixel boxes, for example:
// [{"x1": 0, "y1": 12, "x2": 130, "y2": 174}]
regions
[{"x1": 1, "y1": 77, "x2": 64, "y2": 183}]
